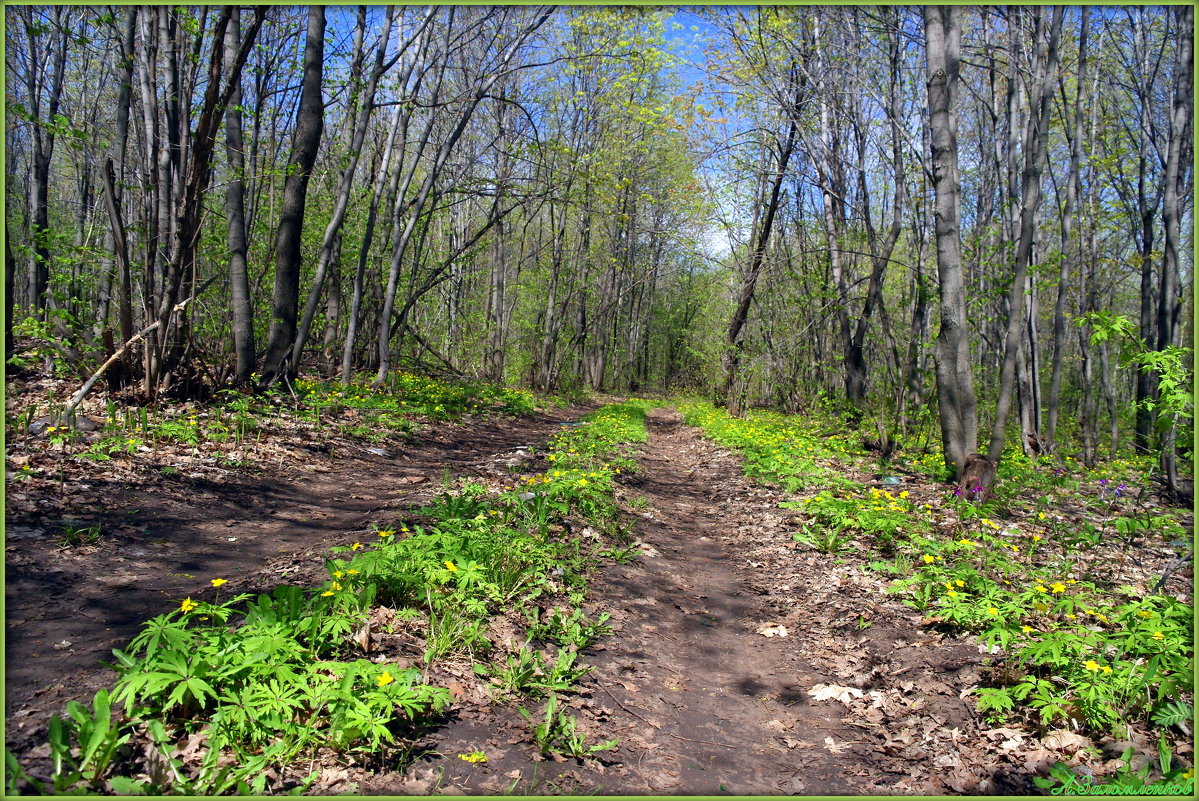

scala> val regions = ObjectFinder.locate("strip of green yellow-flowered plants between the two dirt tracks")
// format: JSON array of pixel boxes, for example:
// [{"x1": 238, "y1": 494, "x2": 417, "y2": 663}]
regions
[{"x1": 7, "y1": 401, "x2": 650, "y2": 795}]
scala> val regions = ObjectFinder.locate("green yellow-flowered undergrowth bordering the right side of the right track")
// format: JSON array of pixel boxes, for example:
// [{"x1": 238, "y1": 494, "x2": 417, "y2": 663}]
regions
[{"x1": 681, "y1": 403, "x2": 1194, "y2": 777}]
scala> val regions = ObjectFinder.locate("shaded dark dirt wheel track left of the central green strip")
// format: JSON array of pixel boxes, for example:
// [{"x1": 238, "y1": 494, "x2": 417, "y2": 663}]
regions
[{"x1": 5, "y1": 408, "x2": 586, "y2": 753}]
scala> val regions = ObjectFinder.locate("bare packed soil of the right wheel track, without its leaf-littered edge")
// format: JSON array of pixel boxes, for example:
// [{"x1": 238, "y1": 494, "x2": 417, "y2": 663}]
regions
[{"x1": 586, "y1": 410, "x2": 866, "y2": 795}]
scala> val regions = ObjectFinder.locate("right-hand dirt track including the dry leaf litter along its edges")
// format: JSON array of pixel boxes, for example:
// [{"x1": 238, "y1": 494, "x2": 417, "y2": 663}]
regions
[{"x1": 407, "y1": 409, "x2": 992, "y2": 795}]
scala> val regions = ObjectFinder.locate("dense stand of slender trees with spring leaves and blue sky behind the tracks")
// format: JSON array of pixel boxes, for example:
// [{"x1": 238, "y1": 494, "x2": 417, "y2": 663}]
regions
[{"x1": 5, "y1": 5, "x2": 1194, "y2": 487}]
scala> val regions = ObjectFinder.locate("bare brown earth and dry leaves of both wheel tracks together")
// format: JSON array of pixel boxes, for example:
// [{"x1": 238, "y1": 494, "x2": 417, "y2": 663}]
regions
[{"x1": 5, "y1": 381, "x2": 1187, "y2": 795}]
